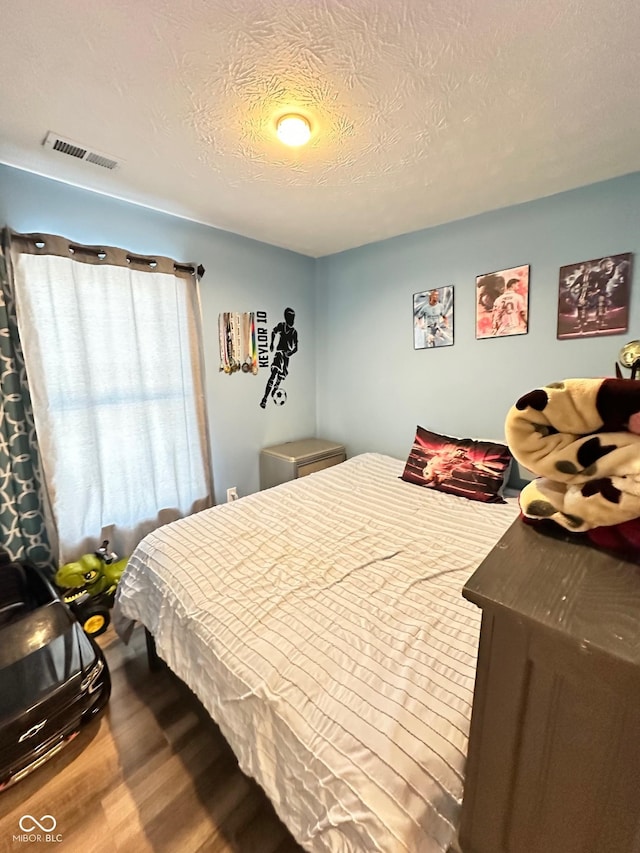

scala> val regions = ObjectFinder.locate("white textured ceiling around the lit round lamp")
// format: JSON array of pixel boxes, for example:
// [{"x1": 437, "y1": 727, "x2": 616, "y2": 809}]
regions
[{"x1": 0, "y1": 0, "x2": 640, "y2": 257}]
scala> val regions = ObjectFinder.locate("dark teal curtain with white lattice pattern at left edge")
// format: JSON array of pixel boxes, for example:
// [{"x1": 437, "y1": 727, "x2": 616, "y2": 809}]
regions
[{"x1": 0, "y1": 233, "x2": 54, "y2": 569}]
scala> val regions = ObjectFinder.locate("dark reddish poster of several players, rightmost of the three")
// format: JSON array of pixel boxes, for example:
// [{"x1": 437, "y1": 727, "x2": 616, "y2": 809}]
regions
[{"x1": 558, "y1": 252, "x2": 633, "y2": 340}]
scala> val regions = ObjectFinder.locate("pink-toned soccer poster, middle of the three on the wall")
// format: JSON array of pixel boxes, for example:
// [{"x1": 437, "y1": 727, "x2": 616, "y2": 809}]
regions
[{"x1": 476, "y1": 265, "x2": 529, "y2": 339}]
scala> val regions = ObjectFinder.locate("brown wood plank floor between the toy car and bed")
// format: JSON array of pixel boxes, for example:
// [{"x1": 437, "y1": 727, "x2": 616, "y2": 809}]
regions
[{"x1": 0, "y1": 628, "x2": 302, "y2": 853}]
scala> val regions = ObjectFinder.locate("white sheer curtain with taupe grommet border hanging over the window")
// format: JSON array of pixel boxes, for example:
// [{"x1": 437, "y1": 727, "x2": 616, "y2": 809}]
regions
[{"x1": 9, "y1": 235, "x2": 212, "y2": 563}]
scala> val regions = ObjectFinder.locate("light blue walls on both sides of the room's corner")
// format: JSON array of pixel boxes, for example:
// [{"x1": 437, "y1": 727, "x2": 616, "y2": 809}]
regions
[{"x1": 5, "y1": 165, "x2": 640, "y2": 501}]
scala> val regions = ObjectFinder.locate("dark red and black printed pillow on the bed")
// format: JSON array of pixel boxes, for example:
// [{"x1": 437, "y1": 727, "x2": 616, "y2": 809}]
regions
[{"x1": 401, "y1": 426, "x2": 513, "y2": 503}]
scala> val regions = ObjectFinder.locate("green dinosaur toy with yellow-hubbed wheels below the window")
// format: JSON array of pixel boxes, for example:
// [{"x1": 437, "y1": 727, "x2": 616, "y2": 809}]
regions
[{"x1": 53, "y1": 540, "x2": 129, "y2": 637}]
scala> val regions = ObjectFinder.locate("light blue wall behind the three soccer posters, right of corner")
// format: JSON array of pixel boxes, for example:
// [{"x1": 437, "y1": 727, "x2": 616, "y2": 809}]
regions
[{"x1": 316, "y1": 173, "x2": 640, "y2": 470}]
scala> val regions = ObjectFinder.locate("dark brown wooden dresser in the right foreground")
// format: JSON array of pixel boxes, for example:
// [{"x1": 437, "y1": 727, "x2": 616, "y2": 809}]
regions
[{"x1": 460, "y1": 520, "x2": 640, "y2": 853}]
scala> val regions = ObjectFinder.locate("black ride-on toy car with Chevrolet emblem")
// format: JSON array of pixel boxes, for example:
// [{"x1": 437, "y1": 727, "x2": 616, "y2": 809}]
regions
[{"x1": 0, "y1": 562, "x2": 111, "y2": 791}]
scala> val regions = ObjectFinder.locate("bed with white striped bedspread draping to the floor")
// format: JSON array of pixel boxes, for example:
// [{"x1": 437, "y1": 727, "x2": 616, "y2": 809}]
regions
[{"x1": 114, "y1": 453, "x2": 518, "y2": 853}]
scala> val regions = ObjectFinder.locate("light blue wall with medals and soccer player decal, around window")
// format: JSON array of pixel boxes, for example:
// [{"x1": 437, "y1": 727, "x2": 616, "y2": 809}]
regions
[{"x1": 0, "y1": 164, "x2": 316, "y2": 502}]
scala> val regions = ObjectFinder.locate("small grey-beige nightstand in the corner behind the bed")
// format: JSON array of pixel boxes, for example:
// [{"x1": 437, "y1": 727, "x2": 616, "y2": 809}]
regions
[{"x1": 260, "y1": 438, "x2": 347, "y2": 489}]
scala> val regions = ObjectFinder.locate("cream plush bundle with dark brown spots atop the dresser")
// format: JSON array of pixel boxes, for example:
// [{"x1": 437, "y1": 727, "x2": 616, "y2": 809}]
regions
[{"x1": 505, "y1": 379, "x2": 640, "y2": 543}]
